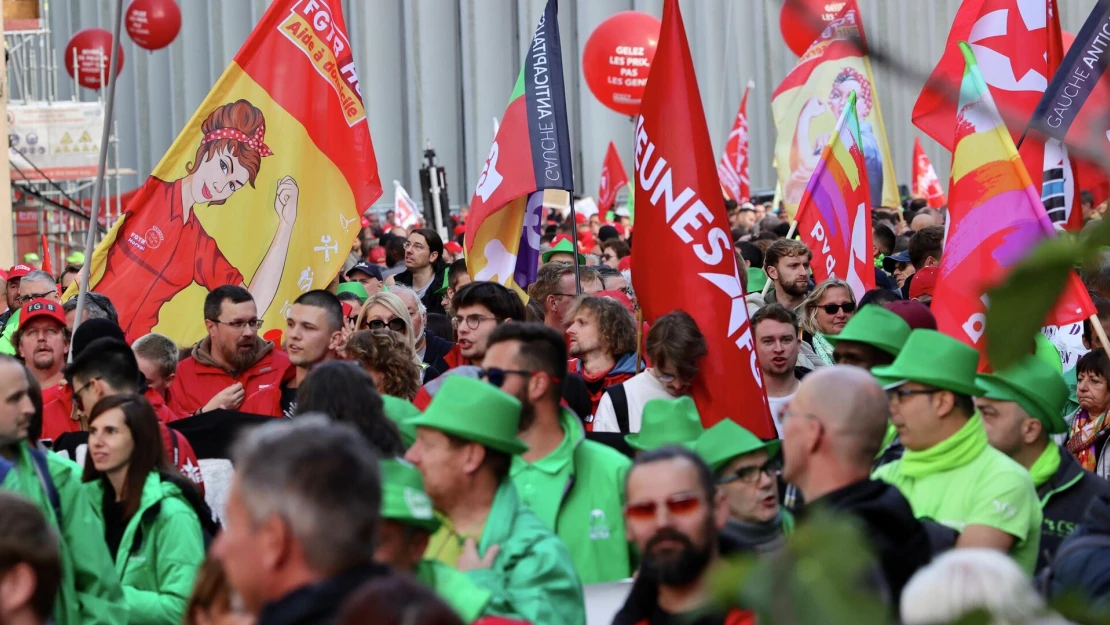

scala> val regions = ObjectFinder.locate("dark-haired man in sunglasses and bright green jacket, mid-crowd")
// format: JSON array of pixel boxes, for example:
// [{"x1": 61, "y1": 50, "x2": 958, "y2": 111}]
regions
[{"x1": 482, "y1": 323, "x2": 634, "y2": 584}]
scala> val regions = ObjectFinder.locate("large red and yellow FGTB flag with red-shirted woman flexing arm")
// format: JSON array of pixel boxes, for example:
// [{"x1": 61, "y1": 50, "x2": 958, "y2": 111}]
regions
[{"x1": 70, "y1": 0, "x2": 382, "y2": 344}]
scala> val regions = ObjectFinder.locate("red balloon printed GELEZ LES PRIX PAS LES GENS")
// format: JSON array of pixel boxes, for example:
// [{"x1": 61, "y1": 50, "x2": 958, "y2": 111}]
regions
[{"x1": 582, "y1": 11, "x2": 663, "y2": 117}]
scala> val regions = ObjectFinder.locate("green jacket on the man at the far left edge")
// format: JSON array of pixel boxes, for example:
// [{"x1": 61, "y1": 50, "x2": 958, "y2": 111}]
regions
[{"x1": 0, "y1": 442, "x2": 128, "y2": 625}]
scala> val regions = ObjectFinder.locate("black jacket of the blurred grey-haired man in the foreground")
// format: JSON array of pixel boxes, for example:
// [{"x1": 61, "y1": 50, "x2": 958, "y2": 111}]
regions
[{"x1": 258, "y1": 564, "x2": 390, "y2": 625}]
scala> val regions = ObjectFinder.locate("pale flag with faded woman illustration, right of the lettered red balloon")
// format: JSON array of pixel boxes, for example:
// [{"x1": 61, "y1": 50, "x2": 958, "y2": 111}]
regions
[{"x1": 770, "y1": 0, "x2": 901, "y2": 215}]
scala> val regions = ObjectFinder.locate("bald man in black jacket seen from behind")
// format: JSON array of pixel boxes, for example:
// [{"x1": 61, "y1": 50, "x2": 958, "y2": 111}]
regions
[{"x1": 783, "y1": 365, "x2": 932, "y2": 611}]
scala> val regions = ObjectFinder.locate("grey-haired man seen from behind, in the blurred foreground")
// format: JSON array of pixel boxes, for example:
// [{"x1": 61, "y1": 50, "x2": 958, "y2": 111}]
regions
[{"x1": 212, "y1": 414, "x2": 389, "y2": 625}]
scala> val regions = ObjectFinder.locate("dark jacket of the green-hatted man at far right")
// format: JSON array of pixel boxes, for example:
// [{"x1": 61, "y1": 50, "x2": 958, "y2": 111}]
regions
[{"x1": 1037, "y1": 443, "x2": 1110, "y2": 571}]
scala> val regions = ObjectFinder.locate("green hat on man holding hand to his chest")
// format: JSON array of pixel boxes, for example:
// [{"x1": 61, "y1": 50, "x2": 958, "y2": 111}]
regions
[{"x1": 408, "y1": 375, "x2": 528, "y2": 455}]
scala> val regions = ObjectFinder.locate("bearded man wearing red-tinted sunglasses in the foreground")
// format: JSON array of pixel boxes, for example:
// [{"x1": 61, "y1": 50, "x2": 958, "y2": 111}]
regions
[{"x1": 613, "y1": 445, "x2": 755, "y2": 625}]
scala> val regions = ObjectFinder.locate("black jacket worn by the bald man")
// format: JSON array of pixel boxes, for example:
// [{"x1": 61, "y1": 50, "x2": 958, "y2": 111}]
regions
[{"x1": 809, "y1": 480, "x2": 932, "y2": 606}]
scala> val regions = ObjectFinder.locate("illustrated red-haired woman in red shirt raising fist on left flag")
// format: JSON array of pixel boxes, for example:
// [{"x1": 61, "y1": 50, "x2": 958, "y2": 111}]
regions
[{"x1": 95, "y1": 100, "x2": 300, "y2": 342}]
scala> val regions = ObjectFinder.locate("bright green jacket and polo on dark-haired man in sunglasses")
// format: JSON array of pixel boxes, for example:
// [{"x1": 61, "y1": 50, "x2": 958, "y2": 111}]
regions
[{"x1": 512, "y1": 410, "x2": 635, "y2": 584}]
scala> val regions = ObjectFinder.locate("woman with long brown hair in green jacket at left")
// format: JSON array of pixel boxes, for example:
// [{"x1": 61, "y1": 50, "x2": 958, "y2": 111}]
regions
[{"x1": 82, "y1": 395, "x2": 204, "y2": 625}]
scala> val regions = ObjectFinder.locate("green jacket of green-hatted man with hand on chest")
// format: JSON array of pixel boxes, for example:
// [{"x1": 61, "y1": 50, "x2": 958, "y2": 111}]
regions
[{"x1": 466, "y1": 480, "x2": 586, "y2": 625}]
